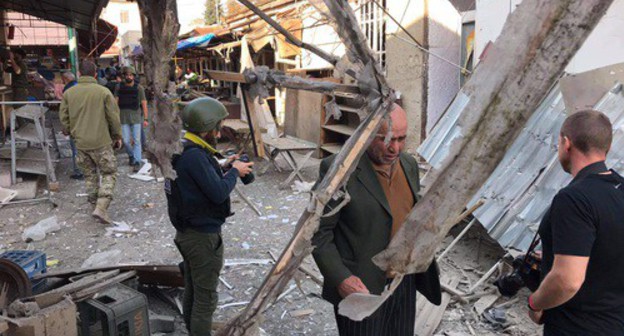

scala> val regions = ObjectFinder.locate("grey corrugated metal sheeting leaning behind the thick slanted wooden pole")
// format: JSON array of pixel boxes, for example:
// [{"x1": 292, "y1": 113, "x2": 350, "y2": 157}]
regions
[{"x1": 419, "y1": 86, "x2": 624, "y2": 250}]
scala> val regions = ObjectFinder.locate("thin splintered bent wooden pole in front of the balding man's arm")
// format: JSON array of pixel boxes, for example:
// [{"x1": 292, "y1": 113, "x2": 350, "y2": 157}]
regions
[{"x1": 217, "y1": 0, "x2": 395, "y2": 336}]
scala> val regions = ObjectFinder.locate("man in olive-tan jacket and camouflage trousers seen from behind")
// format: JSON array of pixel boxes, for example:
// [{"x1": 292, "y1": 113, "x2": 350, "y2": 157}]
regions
[{"x1": 60, "y1": 61, "x2": 121, "y2": 224}]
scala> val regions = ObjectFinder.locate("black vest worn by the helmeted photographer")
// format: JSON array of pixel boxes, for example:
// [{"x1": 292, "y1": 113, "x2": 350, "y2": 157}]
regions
[{"x1": 165, "y1": 141, "x2": 233, "y2": 232}]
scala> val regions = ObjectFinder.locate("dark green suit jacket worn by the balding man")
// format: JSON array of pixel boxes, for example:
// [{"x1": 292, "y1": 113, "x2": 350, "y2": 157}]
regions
[{"x1": 312, "y1": 154, "x2": 442, "y2": 305}]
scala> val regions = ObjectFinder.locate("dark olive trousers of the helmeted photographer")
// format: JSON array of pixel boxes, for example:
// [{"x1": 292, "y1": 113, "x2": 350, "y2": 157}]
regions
[{"x1": 175, "y1": 229, "x2": 223, "y2": 336}]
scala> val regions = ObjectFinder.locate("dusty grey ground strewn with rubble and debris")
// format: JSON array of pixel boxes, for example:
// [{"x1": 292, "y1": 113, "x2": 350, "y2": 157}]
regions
[{"x1": 0, "y1": 148, "x2": 538, "y2": 336}]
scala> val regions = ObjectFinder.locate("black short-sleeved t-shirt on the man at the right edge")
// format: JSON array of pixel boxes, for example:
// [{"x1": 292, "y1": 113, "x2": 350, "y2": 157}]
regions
[{"x1": 539, "y1": 162, "x2": 624, "y2": 336}]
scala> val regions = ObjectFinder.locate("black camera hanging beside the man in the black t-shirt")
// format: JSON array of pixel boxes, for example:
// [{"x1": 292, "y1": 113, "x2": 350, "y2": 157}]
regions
[{"x1": 494, "y1": 251, "x2": 541, "y2": 297}]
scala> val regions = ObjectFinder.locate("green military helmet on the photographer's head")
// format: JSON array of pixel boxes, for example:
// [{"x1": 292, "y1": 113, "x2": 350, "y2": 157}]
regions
[{"x1": 182, "y1": 97, "x2": 228, "y2": 134}]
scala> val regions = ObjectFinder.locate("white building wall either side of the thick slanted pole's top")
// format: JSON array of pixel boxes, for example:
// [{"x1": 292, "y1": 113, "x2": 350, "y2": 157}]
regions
[{"x1": 475, "y1": 0, "x2": 624, "y2": 74}]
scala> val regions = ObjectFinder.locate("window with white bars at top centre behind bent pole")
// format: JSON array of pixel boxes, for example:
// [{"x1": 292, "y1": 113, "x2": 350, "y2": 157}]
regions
[{"x1": 356, "y1": 0, "x2": 386, "y2": 71}]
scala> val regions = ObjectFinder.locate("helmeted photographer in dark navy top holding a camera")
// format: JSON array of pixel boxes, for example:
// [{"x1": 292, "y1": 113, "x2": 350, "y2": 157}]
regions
[{"x1": 165, "y1": 98, "x2": 253, "y2": 336}]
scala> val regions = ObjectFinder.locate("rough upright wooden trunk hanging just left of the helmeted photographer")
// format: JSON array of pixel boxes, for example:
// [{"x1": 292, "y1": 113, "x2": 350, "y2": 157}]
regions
[{"x1": 137, "y1": 0, "x2": 182, "y2": 178}]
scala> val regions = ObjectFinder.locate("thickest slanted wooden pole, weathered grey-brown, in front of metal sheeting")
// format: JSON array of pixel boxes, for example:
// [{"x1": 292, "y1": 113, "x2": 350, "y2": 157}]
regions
[{"x1": 373, "y1": 0, "x2": 612, "y2": 274}]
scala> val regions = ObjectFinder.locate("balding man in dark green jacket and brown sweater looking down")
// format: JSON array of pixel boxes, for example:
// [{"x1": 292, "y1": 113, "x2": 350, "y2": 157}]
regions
[{"x1": 312, "y1": 105, "x2": 442, "y2": 336}]
